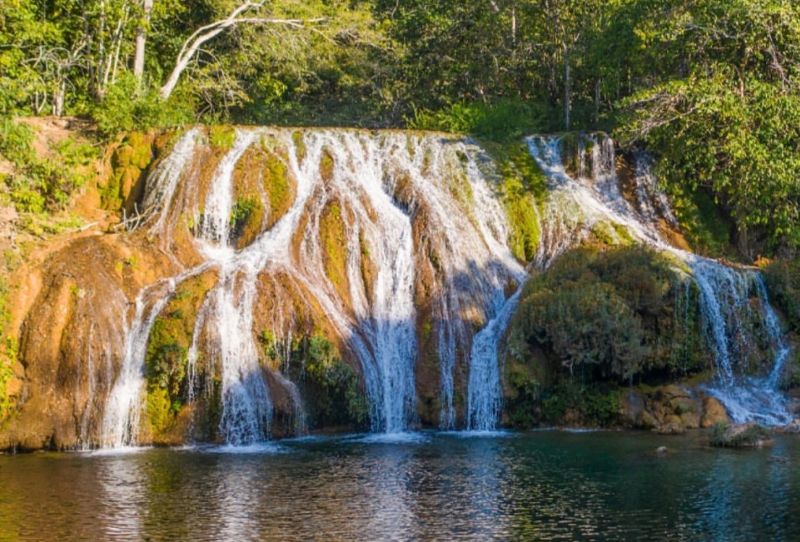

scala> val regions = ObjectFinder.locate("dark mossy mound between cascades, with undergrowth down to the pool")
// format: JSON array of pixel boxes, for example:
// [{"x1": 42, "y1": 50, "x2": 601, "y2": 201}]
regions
[{"x1": 506, "y1": 246, "x2": 710, "y2": 426}]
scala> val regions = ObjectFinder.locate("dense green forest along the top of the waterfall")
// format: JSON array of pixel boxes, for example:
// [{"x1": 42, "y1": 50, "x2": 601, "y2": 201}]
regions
[{"x1": 0, "y1": 0, "x2": 800, "y2": 261}]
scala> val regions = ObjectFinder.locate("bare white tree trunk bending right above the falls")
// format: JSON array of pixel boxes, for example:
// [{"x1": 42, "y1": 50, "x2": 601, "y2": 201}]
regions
[{"x1": 159, "y1": 2, "x2": 322, "y2": 100}]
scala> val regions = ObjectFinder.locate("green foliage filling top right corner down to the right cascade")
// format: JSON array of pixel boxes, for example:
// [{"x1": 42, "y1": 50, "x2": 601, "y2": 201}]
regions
[{"x1": 618, "y1": 0, "x2": 800, "y2": 258}]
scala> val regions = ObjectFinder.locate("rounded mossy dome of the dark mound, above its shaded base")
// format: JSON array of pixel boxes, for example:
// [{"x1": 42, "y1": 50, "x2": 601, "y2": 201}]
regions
[{"x1": 509, "y1": 246, "x2": 707, "y2": 382}]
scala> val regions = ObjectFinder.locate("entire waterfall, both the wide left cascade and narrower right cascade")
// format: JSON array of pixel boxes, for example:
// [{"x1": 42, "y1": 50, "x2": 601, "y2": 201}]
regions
[{"x1": 98, "y1": 128, "x2": 789, "y2": 446}]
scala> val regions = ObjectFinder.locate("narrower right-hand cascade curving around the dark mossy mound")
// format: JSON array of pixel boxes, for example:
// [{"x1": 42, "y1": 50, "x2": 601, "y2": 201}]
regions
[{"x1": 527, "y1": 136, "x2": 792, "y2": 425}]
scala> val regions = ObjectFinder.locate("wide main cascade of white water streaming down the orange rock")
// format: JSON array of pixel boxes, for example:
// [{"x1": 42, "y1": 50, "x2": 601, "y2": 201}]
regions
[{"x1": 102, "y1": 129, "x2": 525, "y2": 446}]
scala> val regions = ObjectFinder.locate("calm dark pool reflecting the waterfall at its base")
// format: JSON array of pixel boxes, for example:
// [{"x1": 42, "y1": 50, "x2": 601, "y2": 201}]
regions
[{"x1": 0, "y1": 432, "x2": 800, "y2": 541}]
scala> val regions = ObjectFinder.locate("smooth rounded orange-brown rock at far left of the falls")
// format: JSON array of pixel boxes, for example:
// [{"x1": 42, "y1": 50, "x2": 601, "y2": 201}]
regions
[{"x1": 0, "y1": 235, "x2": 176, "y2": 449}]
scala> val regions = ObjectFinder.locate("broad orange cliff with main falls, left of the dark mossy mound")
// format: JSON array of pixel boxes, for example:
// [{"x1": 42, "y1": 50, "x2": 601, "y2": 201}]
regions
[{"x1": 3, "y1": 128, "x2": 536, "y2": 448}]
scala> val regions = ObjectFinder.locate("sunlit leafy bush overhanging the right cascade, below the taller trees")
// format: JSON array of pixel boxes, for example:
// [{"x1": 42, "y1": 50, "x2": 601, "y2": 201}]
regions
[{"x1": 616, "y1": 75, "x2": 800, "y2": 257}]
